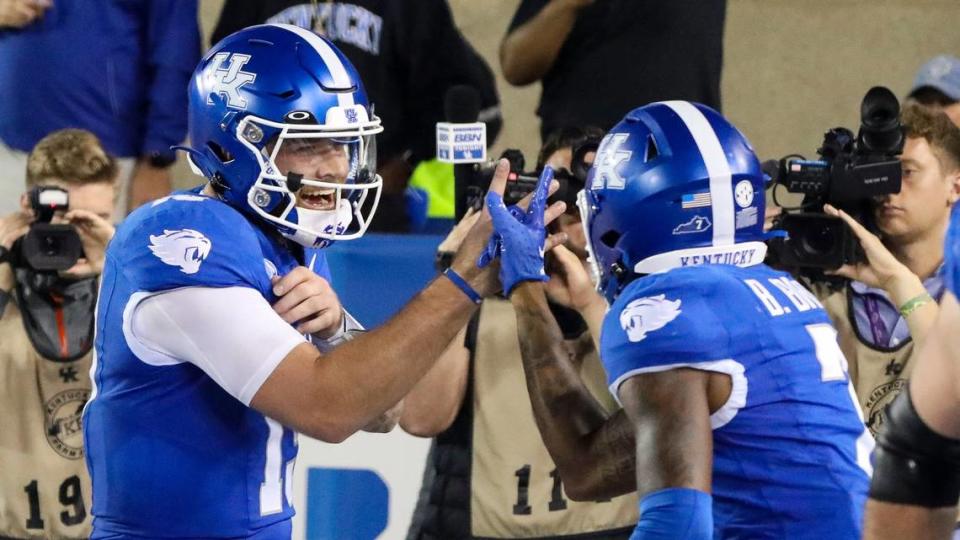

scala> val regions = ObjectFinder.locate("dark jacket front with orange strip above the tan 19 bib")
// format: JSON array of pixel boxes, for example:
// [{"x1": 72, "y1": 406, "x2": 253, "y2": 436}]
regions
[{"x1": 16, "y1": 269, "x2": 97, "y2": 362}]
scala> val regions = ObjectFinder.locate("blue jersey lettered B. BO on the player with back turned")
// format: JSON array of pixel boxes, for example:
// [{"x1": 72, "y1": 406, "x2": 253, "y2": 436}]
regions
[{"x1": 601, "y1": 265, "x2": 873, "y2": 539}]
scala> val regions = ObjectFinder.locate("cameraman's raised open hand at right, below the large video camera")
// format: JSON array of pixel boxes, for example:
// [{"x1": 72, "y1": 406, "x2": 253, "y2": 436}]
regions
[{"x1": 823, "y1": 204, "x2": 925, "y2": 306}]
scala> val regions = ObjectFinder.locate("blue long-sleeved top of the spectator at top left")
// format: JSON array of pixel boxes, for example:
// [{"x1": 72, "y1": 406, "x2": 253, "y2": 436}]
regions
[{"x1": 0, "y1": 0, "x2": 200, "y2": 157}]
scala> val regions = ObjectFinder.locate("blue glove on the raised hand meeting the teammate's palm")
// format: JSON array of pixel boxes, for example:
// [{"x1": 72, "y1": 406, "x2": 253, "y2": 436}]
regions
[{"x1": 477, "y1": 167, "x2": 553, "y2": 297}]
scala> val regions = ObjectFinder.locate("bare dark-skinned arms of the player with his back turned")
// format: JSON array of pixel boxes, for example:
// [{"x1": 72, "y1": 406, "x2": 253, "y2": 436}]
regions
[{"x1": 510, "y1": 282, "x2": 729, "y2": 501}]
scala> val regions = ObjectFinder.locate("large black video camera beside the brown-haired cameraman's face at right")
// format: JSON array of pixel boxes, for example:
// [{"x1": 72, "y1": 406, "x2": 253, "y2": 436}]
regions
[{"x1": 768, "y1": 86, "x2": 904, "y2": 277}]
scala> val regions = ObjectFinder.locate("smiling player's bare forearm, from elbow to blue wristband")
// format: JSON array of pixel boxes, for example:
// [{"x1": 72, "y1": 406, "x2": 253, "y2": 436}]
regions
[{"x1": 318, "y1": 277, "x2": 476, "y2": 433}]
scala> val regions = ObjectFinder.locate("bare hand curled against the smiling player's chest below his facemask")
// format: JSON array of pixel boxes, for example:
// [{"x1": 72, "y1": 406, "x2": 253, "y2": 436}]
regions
[{"x1": 273, "y1": 266, "x2": 343, "y2": 339}]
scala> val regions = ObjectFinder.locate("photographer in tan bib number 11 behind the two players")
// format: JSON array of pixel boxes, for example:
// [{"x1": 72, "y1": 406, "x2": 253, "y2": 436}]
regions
[{"x1": 400, "y1": 128, "x2": 637, "y2": 540}]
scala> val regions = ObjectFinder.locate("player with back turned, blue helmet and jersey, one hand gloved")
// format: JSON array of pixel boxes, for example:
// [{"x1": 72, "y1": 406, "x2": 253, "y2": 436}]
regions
[{"x1": 487, "y1": 101, "x2": 873, "y2": 540}]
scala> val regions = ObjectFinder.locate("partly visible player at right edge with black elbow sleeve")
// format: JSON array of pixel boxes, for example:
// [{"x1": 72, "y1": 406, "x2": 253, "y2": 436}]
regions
[{"x1": 864, "y1": 206, "x2": 960, "y2": 540}]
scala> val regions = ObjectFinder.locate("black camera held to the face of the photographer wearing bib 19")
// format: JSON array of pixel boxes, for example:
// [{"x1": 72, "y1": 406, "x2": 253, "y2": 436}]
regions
[{"x1": 10, "y1": 186, "x2": 83, "y2": 272}]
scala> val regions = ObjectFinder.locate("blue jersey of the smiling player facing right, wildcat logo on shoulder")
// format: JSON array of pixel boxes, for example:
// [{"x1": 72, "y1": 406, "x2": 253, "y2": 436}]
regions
[{"x1": 83, "y1": 194, "x2": 329, "y2": 539}]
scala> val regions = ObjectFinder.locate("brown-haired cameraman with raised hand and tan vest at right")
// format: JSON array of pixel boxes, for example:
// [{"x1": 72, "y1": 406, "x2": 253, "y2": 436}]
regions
[{"x1": 814, "y1": 104, "x2": 960, "y2": 435}]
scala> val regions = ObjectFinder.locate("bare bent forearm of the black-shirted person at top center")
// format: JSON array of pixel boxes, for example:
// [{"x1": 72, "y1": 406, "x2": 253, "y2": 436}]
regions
[{"x1": 500, "y1": 2, "x2": 577, "y2": 86}]
